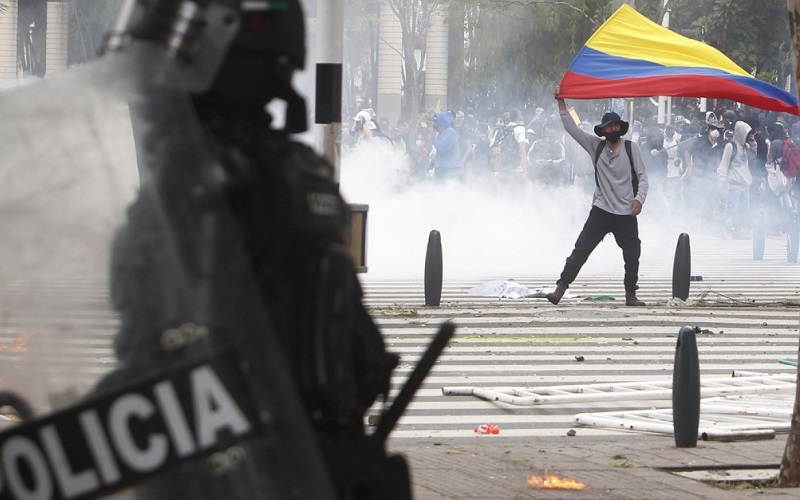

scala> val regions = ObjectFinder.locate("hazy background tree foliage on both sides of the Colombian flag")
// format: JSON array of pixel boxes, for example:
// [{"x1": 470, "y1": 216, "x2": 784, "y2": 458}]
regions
[{"x1": 356, "y1": 0, "x2": 792, "y2": 123}]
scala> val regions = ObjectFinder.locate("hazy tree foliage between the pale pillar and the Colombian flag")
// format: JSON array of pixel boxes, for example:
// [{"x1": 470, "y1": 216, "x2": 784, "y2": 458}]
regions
[{"x1": 455, "y1": 0, "x2": 611, "y2": 116}]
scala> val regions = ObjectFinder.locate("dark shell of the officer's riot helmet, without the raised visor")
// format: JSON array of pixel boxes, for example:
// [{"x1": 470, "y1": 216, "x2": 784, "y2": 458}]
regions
[{"x1": 197, "y1": 0, "x2": 307, "y2": 133}]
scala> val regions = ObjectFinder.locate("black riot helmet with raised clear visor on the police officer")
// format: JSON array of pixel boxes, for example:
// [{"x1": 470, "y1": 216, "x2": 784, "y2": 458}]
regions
[{"x1": 108, "y1": 0, "x2": 314, "y2": 133}]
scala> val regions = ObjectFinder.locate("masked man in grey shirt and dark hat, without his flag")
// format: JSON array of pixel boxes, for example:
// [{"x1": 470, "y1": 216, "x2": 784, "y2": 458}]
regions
[{"x1": 547, "y1": 89, "x2": 648, "y2": 306}]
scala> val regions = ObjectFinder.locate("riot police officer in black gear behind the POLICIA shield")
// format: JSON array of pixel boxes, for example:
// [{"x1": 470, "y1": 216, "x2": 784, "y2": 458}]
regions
[{"x1": 101, "y1": 0, "x2": 411, "y2": 499}]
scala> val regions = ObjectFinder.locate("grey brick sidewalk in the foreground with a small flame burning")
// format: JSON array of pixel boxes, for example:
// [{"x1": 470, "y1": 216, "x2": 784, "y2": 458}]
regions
[{"x1": 389, "y1": 428, "x2": 800, "y2": 500}]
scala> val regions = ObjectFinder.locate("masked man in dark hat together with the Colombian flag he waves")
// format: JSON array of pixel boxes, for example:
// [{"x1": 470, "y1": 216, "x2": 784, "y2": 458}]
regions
[{"x1": 547, "y1": 4, "x2": 798, "y2": 306}]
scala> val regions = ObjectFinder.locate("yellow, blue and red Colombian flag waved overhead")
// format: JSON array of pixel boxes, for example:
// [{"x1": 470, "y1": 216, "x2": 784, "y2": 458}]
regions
[{"x1": 559, "y1": 4, "x2": 798, "y2": 115}]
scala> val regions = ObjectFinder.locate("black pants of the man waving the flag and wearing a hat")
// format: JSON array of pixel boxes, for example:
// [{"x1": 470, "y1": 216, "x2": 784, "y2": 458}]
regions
[{"x1": 558, "y1": 207, "x2": 642, "y2": 293}]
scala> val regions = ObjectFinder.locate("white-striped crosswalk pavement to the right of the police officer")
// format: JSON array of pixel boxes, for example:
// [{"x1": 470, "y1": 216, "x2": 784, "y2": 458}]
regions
[{"x1": 364, "y1": 230, "x2": 800, "y2": 439}]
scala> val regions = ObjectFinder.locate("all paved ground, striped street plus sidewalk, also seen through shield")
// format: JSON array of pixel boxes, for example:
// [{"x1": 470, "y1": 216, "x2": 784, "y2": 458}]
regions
[{"x1": 0, "y1": 229, "x2": 800, "y2": 500}]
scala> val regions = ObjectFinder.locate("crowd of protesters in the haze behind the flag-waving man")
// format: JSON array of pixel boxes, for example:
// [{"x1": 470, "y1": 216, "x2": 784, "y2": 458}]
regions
[{"x1": 347, "y1": 100, "x2": 800, "y2": 239}]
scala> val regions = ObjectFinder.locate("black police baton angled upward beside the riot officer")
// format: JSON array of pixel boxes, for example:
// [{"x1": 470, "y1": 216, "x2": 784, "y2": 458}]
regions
[{"x1": 372, "y1": 321, "x2": 456, "y2": 443}]
